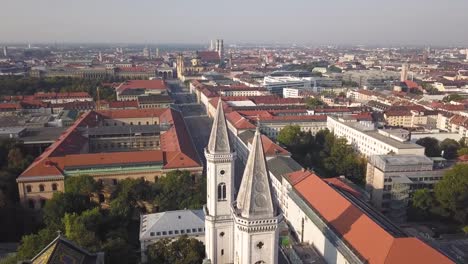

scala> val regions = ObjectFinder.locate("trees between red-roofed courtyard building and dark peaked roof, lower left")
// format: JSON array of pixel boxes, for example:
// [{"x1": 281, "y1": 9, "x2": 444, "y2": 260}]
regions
[{"x1": 1, "y1": 171, "x2": 206, "y2": 263}]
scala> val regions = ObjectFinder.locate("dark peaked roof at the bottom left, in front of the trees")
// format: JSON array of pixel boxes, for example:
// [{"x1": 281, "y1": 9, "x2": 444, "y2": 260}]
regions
[{"x1": 31, "y1": 235, "x2": 104, "y2": 264}]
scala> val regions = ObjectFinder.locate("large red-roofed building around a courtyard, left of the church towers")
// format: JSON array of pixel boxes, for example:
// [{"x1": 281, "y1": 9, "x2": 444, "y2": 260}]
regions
[{"x1": 17, "y1": 108, "x2": 203, "y2": 209}]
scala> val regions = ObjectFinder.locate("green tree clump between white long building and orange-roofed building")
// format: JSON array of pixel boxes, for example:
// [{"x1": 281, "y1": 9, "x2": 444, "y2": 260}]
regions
[{"x1": 277, "y1": 125, "x2": 367, "y2": 184}]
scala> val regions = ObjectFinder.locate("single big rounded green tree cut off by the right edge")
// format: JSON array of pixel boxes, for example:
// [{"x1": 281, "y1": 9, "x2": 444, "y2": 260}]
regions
[{"x1": 435, "y1": 164, "x2": 468, "y2": 223}]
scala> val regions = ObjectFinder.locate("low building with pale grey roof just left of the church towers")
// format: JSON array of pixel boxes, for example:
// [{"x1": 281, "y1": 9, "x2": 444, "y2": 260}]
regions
[{"x1": 140, "y1": 209, "x2": 205, "y2": 262}]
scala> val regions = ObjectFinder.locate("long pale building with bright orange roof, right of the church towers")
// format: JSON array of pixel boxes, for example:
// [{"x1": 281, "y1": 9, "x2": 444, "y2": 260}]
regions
[{"x1": 280, "y1": 170, "x2": 454, "y2": 264}]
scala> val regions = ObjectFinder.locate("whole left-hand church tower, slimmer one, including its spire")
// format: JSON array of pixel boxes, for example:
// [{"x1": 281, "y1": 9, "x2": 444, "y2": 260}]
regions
[{"x1": 204, "y1": 98, "x2": 236, "y2": 264}]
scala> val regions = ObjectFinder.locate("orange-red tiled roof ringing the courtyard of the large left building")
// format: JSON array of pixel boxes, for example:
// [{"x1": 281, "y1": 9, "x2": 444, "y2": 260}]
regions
[{"x1": 20, "y1": 108, "x2": 201, "y2": 178}]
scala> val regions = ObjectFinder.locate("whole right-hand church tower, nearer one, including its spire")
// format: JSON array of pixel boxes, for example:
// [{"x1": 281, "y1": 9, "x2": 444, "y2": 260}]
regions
[{"x1": 232, "y1": 127, "x2": 282, "y2": 264}]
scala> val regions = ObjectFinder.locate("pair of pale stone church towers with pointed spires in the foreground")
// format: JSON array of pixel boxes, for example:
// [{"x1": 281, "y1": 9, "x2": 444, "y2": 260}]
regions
[{"x1": 204, "y1": 101, "x2": 282, "y2": 264}]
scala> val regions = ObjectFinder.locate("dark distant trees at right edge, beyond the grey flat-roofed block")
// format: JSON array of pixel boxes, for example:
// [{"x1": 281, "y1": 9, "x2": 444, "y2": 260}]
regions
[{"x1": 416, "y1": 137, "x2": 468, "y2": 160}]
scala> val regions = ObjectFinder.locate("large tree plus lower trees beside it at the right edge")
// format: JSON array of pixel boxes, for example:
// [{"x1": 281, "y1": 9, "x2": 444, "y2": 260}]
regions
[{"x1": 409, "y1": 164, "x2": 468, "y2": 233}]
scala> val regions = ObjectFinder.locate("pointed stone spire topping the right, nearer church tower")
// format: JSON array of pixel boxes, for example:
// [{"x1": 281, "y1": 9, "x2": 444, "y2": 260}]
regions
[{"x1": 237, "y1": 126, "x2": 276, "y2": 218}]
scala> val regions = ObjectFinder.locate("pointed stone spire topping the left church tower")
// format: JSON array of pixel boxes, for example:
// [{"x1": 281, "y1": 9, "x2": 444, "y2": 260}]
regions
[{"x1": 207, "y1": 97, "x2": 232, "y2": 154}]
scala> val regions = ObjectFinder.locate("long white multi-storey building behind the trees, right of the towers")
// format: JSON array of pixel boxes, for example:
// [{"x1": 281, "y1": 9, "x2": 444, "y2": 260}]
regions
[{"x1": 327, "y1": 116, "x2": 424, "y2": 156}]
